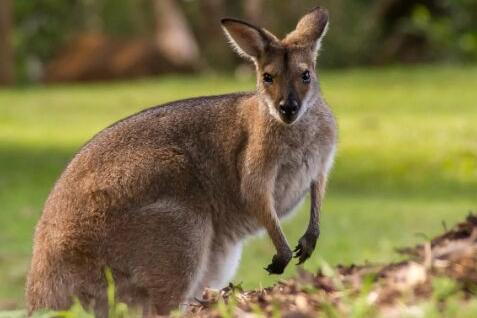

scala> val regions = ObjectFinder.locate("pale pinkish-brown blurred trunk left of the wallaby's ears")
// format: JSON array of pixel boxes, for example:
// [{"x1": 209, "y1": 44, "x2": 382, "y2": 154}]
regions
[{"x1": 154, "y1": 0, "x2": 200, "y2": 70}]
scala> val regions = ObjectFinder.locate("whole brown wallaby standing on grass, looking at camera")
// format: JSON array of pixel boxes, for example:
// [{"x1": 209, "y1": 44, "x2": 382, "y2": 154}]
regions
[{"x1": 26, "y1": 8, "x2": 337, "y2": 316}]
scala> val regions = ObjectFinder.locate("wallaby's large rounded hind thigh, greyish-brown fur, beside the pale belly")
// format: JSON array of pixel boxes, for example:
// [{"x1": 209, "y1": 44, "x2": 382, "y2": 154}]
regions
[{"x1": 111, "y1": 201, "x2": 212, "y2": 316}]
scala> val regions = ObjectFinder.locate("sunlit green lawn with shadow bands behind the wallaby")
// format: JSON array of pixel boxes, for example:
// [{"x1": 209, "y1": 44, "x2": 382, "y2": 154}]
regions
[{"x1": 0, "y1": 66, "x2": 477, "y2": 308}]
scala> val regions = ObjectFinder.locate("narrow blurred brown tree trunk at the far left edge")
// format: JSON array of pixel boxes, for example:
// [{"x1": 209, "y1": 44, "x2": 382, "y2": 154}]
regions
[{"x1": 0, "y1": 0, "x2": 14, "y2": 85}]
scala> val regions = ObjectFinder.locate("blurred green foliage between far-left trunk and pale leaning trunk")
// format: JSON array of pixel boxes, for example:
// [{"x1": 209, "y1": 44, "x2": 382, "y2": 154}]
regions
[{"x1": 13, "y1": 0, "x2": 152, "y2": 82}]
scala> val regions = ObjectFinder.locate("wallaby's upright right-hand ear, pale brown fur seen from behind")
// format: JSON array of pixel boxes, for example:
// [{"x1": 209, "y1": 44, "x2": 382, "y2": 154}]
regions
[{"x1": 285, "y1": 7, "x2": 329, "y2": 58}]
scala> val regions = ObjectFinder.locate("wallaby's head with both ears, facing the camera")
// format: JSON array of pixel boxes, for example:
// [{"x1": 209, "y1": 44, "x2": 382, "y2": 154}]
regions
[{"x1": 221, "y1": 7, "x2": 328, "y2": 124}]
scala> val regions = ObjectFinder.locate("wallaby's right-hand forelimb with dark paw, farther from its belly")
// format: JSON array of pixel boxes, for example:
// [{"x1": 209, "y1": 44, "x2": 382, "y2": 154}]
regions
[{"x1": 294, "y1": 175, "x2": 326, "y2": 265}]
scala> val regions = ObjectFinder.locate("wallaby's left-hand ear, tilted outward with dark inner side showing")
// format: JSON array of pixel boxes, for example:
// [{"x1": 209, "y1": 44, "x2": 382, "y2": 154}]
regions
[{"x1": 220, "y1": 18, "x2": 277, "y2": 62}]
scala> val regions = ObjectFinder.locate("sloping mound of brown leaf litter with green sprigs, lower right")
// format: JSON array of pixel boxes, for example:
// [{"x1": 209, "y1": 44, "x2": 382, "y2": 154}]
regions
[{"x1": 182, "y1": 213, "x2": 477, "y2": 318}]
